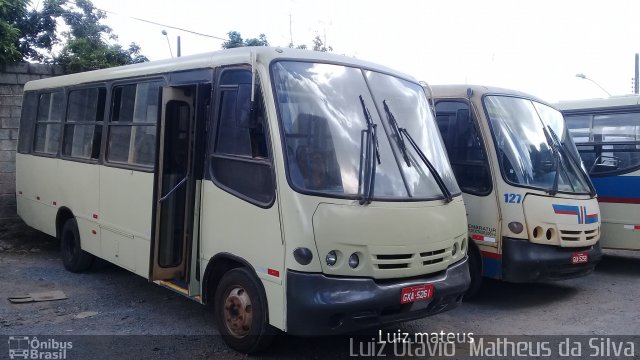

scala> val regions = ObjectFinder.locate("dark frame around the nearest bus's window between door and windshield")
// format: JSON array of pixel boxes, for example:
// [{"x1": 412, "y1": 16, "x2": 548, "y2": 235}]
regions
[{"x1": 204, "y1": 64, "x2": 277, "y2": 209}]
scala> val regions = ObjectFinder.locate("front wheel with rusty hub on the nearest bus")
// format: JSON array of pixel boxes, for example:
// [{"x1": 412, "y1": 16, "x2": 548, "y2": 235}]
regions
[{"x1": 214, "y1": 268, "x2": 276, "y2": 354}]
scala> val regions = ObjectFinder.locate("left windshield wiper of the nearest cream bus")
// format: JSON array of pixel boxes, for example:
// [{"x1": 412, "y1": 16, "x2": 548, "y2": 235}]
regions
[{"x1": 359, "y1": 95, "x2": 380, "y2": 205}]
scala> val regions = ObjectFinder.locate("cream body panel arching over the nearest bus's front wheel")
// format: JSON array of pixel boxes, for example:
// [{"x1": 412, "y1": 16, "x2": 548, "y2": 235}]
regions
[{"x1": 200, "y1": 181, "x2": 285, "y2": 330}]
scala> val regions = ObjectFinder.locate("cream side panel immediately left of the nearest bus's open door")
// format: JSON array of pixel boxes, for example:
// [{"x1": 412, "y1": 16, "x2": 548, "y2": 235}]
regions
[{"x1": 98, "y1": 166, "x2": 153, "y2": 278}]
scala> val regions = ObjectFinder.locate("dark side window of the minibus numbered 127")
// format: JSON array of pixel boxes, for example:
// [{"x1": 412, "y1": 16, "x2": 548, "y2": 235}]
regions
[{"x1": 436, "y1": 101, "x2": 491, "y2": 195}]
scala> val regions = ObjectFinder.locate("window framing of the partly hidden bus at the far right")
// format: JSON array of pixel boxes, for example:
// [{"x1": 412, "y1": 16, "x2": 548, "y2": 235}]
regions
[{"x1": 562, "y1": 106, "x2": 640, "y2": 178}]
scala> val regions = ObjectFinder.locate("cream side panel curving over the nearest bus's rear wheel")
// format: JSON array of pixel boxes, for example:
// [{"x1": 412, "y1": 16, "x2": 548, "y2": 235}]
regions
[{"x1": 58, "y1": 160, "x2": 102, "y2": 256}]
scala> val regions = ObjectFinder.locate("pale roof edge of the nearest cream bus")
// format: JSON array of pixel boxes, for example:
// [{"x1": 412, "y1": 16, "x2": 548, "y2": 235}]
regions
[{"x1": 24, "y1": 46, "x2": 416, "y2": 91}]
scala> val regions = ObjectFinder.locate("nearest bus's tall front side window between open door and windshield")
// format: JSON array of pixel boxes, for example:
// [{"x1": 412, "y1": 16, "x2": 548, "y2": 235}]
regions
[{"x1": 210, "y1": 69, "x2": 275, "y2": 205}]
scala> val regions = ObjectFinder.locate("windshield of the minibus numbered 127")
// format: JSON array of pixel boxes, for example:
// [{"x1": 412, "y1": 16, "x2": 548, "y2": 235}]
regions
[{"x1": 484, "y1": 95, "x2": 591, "y2": 194}]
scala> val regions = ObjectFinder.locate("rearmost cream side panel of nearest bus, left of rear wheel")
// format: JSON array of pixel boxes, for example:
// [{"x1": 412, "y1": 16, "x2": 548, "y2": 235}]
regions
[{"x1": 16, "y1": 154, "x2": 60, "y2": 236}]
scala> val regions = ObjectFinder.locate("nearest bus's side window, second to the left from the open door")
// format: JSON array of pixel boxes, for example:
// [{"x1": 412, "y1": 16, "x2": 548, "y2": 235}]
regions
[{"x1": 62, "y1": 88, "x2": 107, "y2": 160}]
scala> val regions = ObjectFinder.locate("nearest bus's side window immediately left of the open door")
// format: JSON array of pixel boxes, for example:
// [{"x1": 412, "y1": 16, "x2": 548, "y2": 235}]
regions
[{"x1": 107, "y1": 81, "x2": 161, "y2": 167}]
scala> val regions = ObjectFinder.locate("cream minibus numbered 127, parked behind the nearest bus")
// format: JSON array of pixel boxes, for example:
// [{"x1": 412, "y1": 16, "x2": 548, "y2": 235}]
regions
[{"x1": 427, "y1": 85, "x2": 601, "y2": 296}]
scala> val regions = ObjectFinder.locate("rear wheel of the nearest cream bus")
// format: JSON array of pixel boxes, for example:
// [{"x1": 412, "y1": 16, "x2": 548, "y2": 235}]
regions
[{"x1": 60, "y1": 218, "x2": 95, "y2": 273}]
